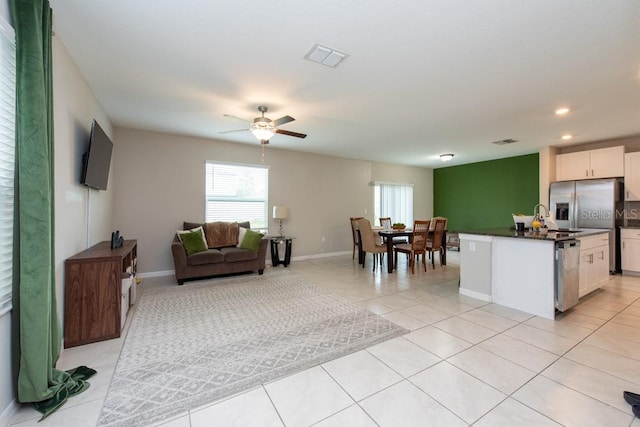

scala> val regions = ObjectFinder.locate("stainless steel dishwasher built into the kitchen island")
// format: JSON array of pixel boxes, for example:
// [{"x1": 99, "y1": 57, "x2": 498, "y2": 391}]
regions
[{"x1": 555, "y1": 239, "x2": 580, "y2": 311}]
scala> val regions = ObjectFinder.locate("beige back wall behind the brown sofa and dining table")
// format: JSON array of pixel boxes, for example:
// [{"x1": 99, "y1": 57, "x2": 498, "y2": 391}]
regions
[{"x1": 113, "y1": 127, "x2": 433, "y2": 273}]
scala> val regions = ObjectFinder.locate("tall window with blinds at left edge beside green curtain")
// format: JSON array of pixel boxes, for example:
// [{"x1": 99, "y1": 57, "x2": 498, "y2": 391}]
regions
[{"x1": 0, "y1": 17, "x2": 16, "y2": 315}]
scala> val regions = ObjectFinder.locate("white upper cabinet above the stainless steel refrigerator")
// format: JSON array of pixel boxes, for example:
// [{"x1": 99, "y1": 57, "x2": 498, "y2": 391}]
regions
[{"x1": 556, "y1": 146, "x2": 624, "y2": 181}]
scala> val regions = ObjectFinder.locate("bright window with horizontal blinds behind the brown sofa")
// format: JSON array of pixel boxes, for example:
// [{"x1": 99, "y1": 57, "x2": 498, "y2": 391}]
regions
[{"x1": 205, "y1": 162, "x2": 269, "y2": 232}]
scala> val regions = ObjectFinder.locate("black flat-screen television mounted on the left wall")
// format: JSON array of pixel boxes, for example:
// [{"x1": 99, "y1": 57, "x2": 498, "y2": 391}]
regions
[{"x1": 81, "y1": 120, "x2": 113, "y2": 190}]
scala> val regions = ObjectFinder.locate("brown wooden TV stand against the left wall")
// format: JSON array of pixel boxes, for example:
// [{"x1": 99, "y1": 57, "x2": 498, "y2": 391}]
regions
[{"x1": 64, "y1": 240, "x2": 137, "y2": 348}]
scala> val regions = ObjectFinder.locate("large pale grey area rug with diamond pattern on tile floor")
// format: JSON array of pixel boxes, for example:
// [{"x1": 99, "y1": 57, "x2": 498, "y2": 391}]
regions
[{"x1": 98, "y1": 271, "x2": 408, "y2": 426}]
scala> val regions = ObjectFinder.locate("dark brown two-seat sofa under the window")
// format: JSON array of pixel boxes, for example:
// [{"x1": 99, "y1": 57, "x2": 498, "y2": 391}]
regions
[{"x1": 171, "y1": 222, "x2": 268, "y2": 285}]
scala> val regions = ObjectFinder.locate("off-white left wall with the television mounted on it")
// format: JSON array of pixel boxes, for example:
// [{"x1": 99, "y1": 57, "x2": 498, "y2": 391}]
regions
[{"x1": 0, "y1": 6, "x2": 117, "y2": 425}]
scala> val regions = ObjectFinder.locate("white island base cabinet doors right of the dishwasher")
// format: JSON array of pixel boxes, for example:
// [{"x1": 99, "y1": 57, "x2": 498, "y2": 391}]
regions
[{"x1": 579, "y1": 233, "x2": 609, "y2": 297}]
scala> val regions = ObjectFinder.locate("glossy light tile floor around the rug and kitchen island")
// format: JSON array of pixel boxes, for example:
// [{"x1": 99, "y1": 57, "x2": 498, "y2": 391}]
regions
[{"x1": 11, "y1": 252, "x2": 640, "y2": 427}]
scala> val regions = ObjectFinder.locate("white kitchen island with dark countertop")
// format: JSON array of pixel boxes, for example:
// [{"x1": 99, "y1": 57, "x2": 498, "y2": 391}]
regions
[{"x1": 459, "y1": 227, "x2": 609, "y2": 319}]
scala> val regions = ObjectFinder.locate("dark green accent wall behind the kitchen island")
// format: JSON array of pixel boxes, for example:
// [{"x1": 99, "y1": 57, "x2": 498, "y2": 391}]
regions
[{"x1": 433, "y1": 153, "x2": 540, "y2": 231}]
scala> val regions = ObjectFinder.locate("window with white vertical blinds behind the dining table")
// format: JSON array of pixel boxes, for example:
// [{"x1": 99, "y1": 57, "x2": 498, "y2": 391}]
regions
[{"x1": 374, "y1": 182, "x2": 413, "y2": 227}]
